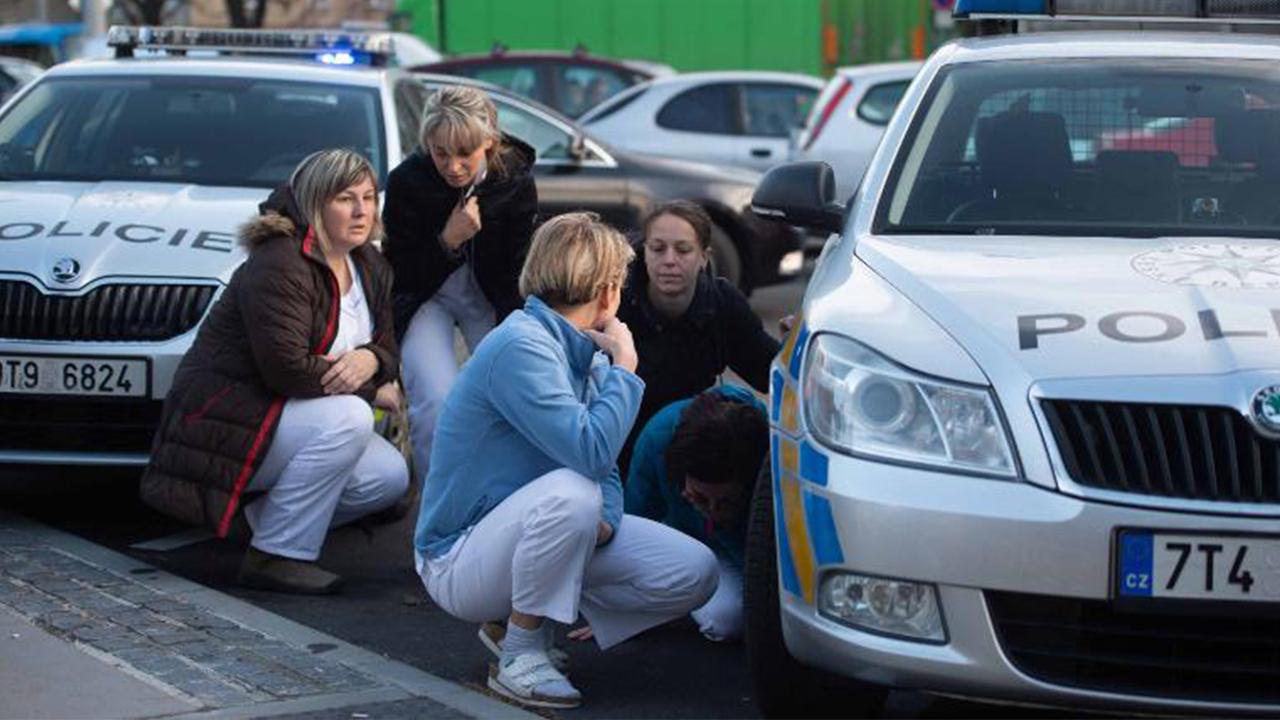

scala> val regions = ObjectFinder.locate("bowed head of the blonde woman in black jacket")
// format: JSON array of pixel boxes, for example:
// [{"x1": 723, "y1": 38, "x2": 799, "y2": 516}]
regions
[{"x1": 419, "y1": 85, "x2": 502, "y2": 188}]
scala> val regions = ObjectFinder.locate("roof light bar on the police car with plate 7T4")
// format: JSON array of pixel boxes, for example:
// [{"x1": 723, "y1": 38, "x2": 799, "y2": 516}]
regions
[{"x1": 954, "y1": 0, "x2": 1280, "y2": 24}]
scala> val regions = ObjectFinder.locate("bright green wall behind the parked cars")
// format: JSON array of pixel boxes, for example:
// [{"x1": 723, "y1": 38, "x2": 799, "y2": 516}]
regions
[{"x1": 397, "y1": 0, "x2": 950, "y2": 74}]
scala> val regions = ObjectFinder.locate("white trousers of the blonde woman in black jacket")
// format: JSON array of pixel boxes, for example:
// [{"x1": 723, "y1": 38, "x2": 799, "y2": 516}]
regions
[{"x1": 401, "y1": 265, "x2": 494, "y2": 478}]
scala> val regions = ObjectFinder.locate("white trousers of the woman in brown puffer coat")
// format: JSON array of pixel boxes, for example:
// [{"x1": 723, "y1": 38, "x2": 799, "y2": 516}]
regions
[{"x1": 244, "y1": 395, "x2": 408, "y2": 560}]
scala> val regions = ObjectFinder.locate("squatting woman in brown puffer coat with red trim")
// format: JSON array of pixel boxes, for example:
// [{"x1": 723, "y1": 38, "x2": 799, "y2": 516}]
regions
[{"x1": 142, "y1": 150, "x2": 408, "y2": 593}]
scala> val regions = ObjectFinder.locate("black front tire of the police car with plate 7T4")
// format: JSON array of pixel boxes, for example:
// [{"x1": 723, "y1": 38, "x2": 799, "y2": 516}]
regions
[{"x1": 742, "y1": 464, "x2": 888, "y2": 717}]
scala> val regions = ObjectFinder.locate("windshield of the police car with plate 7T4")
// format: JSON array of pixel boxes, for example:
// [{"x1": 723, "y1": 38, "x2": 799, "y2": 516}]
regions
[{"x1": 876, "y1": 58, "x2": 1280, "y2": 237}]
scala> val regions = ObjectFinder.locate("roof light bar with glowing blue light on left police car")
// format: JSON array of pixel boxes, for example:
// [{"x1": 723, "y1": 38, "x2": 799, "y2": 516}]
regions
[{"x1": 106, "y1": 26, "x2": 394, "y2": 65}]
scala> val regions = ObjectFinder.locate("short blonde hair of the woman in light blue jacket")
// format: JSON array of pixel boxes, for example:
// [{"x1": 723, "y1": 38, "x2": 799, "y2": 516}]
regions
[{"x1": 520, "y1": 213, "x2": 636, "y2": 307}]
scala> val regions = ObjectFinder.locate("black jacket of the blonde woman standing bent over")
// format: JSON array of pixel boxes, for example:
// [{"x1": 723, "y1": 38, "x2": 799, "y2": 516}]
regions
[{"x1": 383, "y1": 136, "x2": 538, "y2": 338}]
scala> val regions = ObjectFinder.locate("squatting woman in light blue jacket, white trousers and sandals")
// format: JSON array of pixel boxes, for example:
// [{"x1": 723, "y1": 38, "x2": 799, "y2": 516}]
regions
[{"x1": 413, "y1": 213, "x2": 718, "y2": 707}]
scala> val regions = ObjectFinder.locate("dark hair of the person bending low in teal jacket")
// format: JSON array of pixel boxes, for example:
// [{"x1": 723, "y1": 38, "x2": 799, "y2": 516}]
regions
[{"x1": 664, "y1": 391, "x2": 769, "y2": 488}]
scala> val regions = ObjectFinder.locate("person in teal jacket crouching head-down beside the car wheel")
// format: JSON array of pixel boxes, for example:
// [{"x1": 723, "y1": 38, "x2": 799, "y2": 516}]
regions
[{"x1": 625, "y1": 386, "x2": 769, "y2": 641}]
